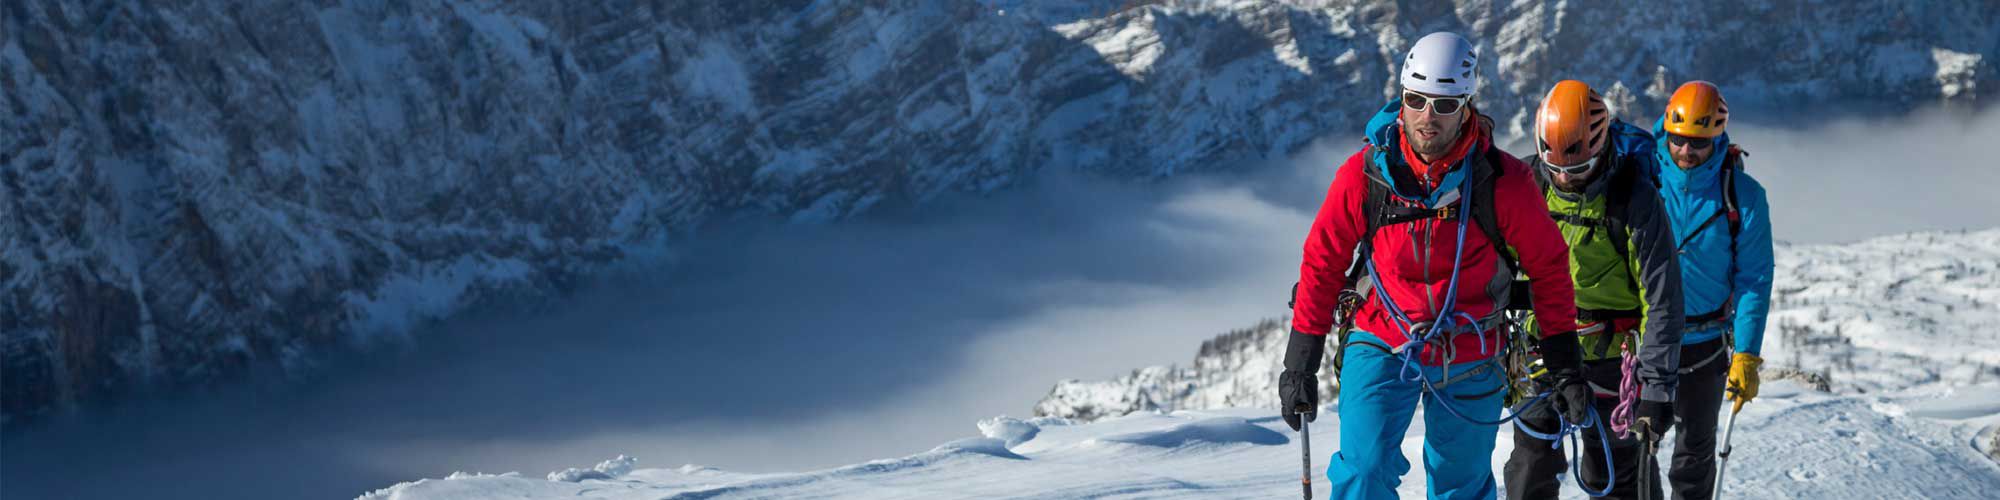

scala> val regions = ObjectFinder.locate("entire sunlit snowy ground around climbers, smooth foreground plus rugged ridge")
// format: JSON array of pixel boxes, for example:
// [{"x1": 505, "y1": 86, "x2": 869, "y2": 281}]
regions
[{"x1": 362, "y1": 230, "x2": 2000, "y2": 500}]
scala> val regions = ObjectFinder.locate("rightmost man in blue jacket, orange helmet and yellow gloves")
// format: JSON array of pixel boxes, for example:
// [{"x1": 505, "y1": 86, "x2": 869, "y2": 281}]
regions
[{"x1": 1654, "y1": 82, "x2": 1774, "y2": 500}]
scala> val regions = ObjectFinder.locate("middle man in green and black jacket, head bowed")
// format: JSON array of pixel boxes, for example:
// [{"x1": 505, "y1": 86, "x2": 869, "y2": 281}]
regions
[{"x1": 1504, "y1": 80, "x2": 1682, "y2": 498}]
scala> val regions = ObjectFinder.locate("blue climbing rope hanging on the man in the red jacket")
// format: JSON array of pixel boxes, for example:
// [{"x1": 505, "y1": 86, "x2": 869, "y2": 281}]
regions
[{"x1": 1366, "y1": 190, "x2": 1618, "y2": 496}]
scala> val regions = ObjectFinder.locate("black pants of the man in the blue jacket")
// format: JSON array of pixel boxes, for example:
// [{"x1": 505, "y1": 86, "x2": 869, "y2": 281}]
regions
[{"x1": 1666, "y1": 336, "x2": 1730, "y2": 500}]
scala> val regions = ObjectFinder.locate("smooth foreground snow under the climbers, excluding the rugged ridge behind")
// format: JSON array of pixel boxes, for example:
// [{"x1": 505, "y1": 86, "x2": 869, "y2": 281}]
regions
[{"x1": 362, "y1": 382, "x2": 2000, "y2": 500}]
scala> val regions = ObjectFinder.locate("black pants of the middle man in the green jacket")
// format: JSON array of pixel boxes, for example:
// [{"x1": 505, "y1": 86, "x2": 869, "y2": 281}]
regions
[{"x1": 1502, "y1": 358, "x2": 1660, "y2": 500}]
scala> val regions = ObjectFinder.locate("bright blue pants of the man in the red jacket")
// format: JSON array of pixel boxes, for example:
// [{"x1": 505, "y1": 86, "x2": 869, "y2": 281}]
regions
[{"x1": 1326, "y1": 330, "x2": 1506, "y2": 498}]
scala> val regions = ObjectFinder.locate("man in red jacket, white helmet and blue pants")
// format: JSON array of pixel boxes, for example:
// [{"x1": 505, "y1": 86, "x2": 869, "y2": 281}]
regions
[{"x1": 1278, "y1": 32, "x2": 1590, "y2": 498}]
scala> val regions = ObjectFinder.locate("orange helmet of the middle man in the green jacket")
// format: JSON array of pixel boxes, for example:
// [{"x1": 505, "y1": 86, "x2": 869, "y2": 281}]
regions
[{"x1": 1534, "y1": 80, "x2": 1612, "y2": 170}]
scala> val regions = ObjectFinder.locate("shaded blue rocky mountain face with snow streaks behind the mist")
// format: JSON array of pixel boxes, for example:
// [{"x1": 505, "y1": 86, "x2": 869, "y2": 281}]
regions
[{"x1": 0, "y1": 0, "x2": 2000, "y2": 420}]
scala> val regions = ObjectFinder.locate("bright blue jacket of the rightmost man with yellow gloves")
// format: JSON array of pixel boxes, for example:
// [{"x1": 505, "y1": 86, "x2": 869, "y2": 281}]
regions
[{"x1": 1652, "y1": 122, "x2": 1774, "y2": 356}]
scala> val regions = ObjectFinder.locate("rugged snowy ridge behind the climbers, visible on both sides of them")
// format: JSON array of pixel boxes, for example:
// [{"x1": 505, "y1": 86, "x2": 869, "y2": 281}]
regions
[{"x1": 1034, "y1": 230, "x2": 2000, "y2": 420}]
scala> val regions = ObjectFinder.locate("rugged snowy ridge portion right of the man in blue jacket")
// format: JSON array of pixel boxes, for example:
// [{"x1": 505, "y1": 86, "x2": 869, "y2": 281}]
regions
[{"x1": 1764, "y1": 230, "x2": 2000, "y2": 394}]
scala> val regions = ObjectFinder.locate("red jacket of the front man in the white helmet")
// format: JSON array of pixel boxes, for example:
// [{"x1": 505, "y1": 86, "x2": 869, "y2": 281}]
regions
[{"x1": 1292, "y1": 111, "x2": 1576, "y2": 364}]
